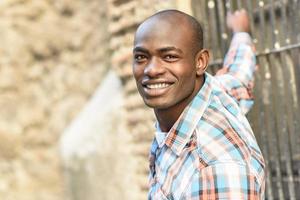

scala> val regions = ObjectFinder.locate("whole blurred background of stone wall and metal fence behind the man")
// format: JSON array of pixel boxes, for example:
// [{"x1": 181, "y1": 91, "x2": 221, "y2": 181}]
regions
[{"x1": 0, "y1": 0, "x2": 300, "y2": 200}]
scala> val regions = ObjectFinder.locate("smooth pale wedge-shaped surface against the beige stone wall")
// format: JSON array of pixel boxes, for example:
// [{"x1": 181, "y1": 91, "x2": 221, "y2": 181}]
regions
[{"x1": 61, "y1": 72, "x2": 141, "y2": 200}]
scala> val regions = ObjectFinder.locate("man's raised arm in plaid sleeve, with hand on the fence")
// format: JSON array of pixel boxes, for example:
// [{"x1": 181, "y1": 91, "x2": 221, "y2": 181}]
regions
[{"x1": 215, "y1": 10, "x2": 256, "y2": 114}]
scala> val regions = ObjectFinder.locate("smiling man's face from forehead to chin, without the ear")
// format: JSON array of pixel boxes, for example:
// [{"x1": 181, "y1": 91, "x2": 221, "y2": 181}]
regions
[{"x1": 133, "y1": 16, "x2": 199, "y2": 109}]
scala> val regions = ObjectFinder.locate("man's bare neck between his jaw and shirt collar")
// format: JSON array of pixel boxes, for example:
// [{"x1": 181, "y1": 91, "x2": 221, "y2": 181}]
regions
[{"x1": 154, "y1": 76, "x2": 204, "y2": 132}]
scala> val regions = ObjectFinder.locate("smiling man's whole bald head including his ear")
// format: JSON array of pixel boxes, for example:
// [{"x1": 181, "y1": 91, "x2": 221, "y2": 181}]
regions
[{"x1": 132, "y1": 10, "x2": 209, "y2": 112}]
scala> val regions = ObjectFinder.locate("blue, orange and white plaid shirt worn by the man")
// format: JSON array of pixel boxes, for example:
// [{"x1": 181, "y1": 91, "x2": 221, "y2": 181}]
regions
[{"x1": 148, "y1": 33, "x2": 265, "y2": 200}]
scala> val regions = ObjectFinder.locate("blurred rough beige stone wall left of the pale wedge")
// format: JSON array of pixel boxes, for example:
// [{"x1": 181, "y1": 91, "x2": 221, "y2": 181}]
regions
[{"x1": 0, "y1": 0, "x2": 110, "y2": 200}]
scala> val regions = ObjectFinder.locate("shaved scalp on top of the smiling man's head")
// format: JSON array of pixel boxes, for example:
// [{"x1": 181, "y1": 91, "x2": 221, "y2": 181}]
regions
[{"x1": 135, "y1": 10, "x2": 203, "y2": 52}]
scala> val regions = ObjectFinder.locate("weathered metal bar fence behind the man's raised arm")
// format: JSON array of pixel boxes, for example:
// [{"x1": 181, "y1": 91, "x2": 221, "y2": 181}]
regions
[{"x1": 192, "y1": 0, "x2": 300, "y2": 200}]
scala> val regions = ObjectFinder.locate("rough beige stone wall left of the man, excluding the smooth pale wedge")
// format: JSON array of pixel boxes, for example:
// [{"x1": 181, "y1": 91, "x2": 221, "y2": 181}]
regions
[{"x1": 0, "y1": 0, "x2": 190, "y2": 200}]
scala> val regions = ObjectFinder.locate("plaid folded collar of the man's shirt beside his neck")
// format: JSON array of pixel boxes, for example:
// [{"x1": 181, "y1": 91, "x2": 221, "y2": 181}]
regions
[{"x1": 156, "y1": 73, "x2": 213, "y2": 156}]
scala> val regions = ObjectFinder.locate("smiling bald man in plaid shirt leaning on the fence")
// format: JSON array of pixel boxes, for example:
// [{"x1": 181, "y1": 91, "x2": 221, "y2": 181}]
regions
[{"x1": 133, "y1": 10, "x2": 264, "y2": 200}]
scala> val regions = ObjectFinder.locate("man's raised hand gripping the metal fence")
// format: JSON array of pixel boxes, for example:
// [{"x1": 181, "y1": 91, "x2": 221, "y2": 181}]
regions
[{"x1": 226, "y1": 9, "x2": 250, "y2": 33}]
